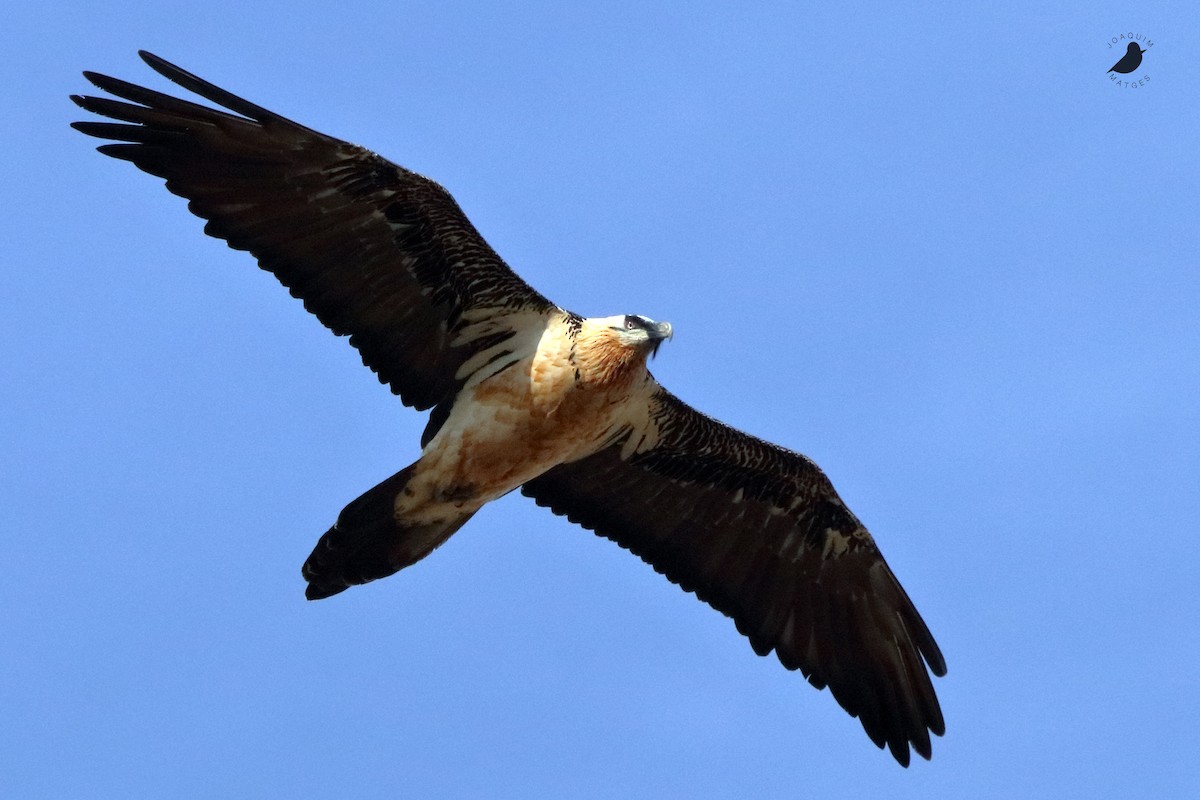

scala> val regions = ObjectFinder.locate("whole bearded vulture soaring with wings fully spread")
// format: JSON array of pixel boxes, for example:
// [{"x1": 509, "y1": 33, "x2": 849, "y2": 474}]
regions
[{"x1": 72, "y1": 52, "x2": 946, "y2": 765}]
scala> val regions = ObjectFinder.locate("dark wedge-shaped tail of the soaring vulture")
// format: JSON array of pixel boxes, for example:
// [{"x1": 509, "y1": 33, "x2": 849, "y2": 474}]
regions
[{"x1": 300, "y1": 467, "x2": 474, "y2": 600}]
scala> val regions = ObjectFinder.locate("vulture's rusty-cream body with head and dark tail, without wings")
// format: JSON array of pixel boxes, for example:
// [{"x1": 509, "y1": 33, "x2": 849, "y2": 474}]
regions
[{"x1": 319, "y1": 313, "x2": 670, "y2": 599}]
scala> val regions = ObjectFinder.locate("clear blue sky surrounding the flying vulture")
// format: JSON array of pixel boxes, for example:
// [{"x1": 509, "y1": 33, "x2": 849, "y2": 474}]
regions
[{"x1": 0, "y1": 0, "x2": 1200, "y2": 798}]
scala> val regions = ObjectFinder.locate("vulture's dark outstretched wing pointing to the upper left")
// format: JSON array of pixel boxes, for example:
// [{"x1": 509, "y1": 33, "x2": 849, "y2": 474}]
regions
[{"x1": 72, "y1": 52, "x2": 554, "y2": 409}]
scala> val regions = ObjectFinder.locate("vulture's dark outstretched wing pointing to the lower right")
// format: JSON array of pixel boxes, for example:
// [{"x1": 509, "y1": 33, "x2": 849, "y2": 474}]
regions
[{"x1": 522, "y1": 387, "x2": 946, "y2": 765}]
